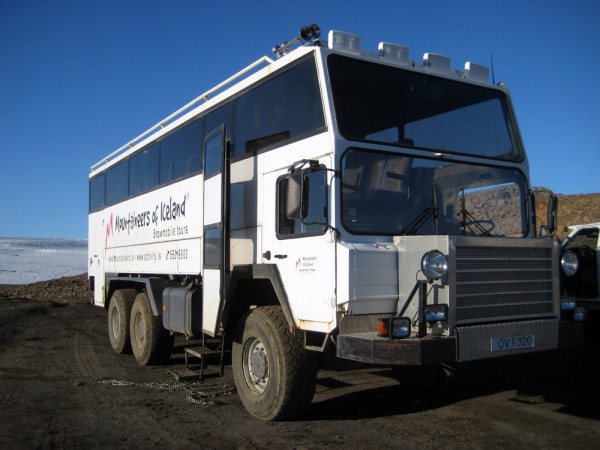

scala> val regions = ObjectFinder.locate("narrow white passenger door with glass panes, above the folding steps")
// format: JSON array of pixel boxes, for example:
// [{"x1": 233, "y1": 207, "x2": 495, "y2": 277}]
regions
[{"x1": 202, "y1": 125, "x2": 228, "y2": 336}]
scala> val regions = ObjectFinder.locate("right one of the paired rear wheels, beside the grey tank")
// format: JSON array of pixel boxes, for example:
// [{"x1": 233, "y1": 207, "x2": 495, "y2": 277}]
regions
[{"x1": 129, "y1": 292, "x2": 173, "y2": 366}]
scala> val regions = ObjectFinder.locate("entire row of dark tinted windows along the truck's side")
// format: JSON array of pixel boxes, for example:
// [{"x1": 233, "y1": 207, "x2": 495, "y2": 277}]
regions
[{"x1": 89, "y1": 58, "x2": 325, "y2": 212}]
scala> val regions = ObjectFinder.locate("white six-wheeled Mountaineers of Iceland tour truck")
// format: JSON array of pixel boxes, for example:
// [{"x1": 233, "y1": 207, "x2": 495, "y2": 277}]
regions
[{"x1": 89, "y1": 25, "x2": 561, "y2": 420}]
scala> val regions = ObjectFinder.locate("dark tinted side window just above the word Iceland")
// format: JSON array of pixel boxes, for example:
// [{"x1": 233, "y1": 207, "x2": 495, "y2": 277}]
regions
[{"x1": 160, "y1": 120, "x2": 202, "y2": 184}]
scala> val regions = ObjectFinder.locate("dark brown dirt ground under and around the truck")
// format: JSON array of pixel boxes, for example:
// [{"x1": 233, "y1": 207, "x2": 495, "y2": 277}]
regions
[{"x1": 0, "y1": 279, "x2": 600, "y2": 449}]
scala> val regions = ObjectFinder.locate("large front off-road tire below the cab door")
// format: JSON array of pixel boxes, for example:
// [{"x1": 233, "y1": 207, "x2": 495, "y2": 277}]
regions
[{"x1": 232, "y1": 306, "x2": 317, "y2": 420}]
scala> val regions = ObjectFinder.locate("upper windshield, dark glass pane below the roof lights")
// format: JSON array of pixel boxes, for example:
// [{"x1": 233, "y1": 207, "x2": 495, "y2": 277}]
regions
[{"x1": 328, "y1": 55, "x2": 522, "y2": 161}]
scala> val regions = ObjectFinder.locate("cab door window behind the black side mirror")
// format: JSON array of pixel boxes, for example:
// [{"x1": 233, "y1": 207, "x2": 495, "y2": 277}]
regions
[{"x1": 277, "y1": 170, "x2": 327, "y2": 239}]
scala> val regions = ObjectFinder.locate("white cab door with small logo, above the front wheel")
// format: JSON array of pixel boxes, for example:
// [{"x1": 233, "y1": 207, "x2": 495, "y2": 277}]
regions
[{"x1": 262, "y1": 159, "x2": 336, "y2": 332}]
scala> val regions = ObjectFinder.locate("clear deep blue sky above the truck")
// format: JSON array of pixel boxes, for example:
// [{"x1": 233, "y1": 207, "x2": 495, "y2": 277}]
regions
[{"x1": 0, "y1": 0, "x2": 600, "y2": 238}]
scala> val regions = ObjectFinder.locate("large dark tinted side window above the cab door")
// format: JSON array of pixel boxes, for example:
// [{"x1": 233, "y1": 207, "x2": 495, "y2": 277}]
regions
[{"x1": 234, "y1": 58, "x2": 325, "y2": 156}]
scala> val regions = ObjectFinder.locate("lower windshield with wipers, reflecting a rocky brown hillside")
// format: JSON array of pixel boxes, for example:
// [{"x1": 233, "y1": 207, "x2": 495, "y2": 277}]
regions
[{"x1": 341, "y1": 149, "x2": 527, "y2": 237}]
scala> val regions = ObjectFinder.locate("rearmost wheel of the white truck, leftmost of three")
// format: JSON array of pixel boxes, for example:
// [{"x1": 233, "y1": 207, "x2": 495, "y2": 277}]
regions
[{"x1": 108, "y1": 289, "x2": 137, "y2": 354}]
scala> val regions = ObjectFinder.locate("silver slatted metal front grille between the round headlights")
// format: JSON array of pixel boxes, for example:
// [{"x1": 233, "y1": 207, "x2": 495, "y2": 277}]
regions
[{"x1": 456, "y1": 246, "x2": 554, "y2": 325}]
